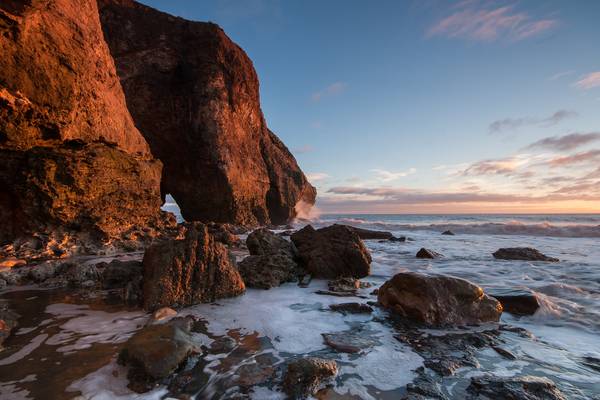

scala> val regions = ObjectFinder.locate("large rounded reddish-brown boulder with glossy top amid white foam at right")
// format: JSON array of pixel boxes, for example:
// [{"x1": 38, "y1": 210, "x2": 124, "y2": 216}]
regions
[{"x1": 377, "y1": 272, "x2": 502, "y2": 326}]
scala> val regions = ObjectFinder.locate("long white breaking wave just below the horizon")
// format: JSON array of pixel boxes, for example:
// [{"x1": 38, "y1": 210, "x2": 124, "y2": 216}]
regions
[{"x1": 312, "y1": 218, "x2": 600, "y2": 238}]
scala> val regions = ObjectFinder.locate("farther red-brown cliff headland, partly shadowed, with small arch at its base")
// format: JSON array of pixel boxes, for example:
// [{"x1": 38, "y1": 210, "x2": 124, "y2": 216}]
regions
[{"x1": 99, "y1": 0, "x2": 316, "y2": 224}]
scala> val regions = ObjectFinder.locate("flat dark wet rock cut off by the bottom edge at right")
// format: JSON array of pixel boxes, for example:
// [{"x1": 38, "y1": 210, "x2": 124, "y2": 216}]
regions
[{"x1": 467, "y1": 376, "x2": 566, "y2": 400}]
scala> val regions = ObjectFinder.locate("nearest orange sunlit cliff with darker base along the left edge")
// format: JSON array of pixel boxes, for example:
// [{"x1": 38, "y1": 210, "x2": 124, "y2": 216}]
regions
[{"x1": 0, "y1": 0, "x2": 166, "y2": 246}]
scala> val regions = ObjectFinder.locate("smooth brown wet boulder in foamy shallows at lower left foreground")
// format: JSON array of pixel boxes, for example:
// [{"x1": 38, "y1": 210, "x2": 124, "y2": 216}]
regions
[{"x1": 119, "y1": 318, "x2": 200, "y2": 392}]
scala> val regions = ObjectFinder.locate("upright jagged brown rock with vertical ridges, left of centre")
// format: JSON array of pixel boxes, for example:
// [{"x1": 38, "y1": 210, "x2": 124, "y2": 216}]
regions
[{"x1": 143, "y1": 222, "x2": 245, "y2": 310}]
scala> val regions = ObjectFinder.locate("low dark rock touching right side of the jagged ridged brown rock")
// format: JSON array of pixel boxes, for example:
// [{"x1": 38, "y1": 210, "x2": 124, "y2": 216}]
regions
[{"x1": 238, "y1": 254, "x2": 299, "y2": 289}]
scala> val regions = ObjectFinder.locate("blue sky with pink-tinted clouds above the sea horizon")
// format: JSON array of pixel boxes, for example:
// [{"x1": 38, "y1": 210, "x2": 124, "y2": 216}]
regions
[{"x1": 142, "y1": 0, "x2": 600, "y2": 213}]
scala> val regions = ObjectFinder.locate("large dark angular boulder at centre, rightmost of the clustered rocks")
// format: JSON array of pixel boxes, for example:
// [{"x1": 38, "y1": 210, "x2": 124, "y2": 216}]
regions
[{"x1": 291, "y1": 225, "x2": 371, "y2": 279}]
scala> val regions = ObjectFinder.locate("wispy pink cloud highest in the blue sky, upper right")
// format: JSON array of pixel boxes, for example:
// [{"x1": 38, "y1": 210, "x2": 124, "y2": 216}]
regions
[{"x1": 426, "y1": 2, "x2": 558, "y2": 42}]
